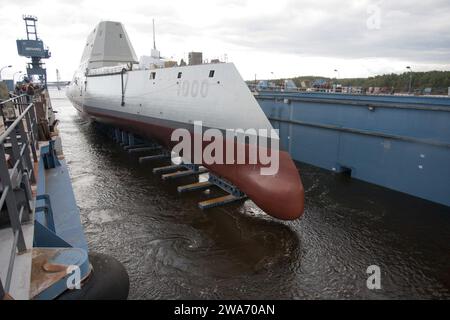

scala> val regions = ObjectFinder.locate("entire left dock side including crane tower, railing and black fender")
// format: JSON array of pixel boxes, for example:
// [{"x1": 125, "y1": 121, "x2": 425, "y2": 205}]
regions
[{"x1": 0, "y1": 15, "x2": 129, "y2": 301}]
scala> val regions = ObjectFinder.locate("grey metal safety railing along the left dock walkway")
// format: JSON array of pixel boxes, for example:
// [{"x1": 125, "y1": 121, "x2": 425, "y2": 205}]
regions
[{"x1": 0, "y1": 95, "x2": 39, "y2": 299}]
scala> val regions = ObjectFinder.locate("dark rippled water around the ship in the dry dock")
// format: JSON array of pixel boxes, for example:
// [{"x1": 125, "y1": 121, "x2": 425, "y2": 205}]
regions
[{"x1": 51, "y1": 90, "x2": 450, "y2": 299}]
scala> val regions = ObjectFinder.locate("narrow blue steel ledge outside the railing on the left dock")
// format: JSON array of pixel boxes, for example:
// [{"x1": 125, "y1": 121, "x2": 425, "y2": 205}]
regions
[{"x1": 33, "y1": 140, "x2": 91, "y2": 300}]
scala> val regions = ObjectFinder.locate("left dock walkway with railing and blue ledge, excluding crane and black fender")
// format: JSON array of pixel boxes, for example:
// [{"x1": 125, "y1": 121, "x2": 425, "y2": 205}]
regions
[{"x1": 0, "y1": 91, "x2": 91, "y2": 300}]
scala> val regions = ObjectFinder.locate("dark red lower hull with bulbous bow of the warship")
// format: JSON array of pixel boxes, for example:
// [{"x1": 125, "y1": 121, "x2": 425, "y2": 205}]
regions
[{"x1": 76, "y1": 102, "x2": 304, "y2": 220}]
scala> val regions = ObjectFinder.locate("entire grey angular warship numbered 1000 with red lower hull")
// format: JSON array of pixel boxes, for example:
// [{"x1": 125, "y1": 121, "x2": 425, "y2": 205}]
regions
[{"x1": 67, "y1": 21, "x2": 304, "y2": 220}]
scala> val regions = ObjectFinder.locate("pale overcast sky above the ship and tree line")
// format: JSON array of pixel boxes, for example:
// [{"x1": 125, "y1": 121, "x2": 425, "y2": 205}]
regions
[{"x1": 0, "y1": 0, "x2": 450, "y2": 80}]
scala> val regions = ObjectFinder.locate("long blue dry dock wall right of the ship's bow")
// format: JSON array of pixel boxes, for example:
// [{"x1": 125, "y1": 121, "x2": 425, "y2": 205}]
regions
[{"x1": 256, "y1": 92, "x2": 450, "y2": 206}]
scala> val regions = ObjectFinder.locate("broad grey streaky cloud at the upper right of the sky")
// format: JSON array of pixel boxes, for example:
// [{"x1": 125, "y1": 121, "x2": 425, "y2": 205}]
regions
[{"x1": 216, "y1": 0, "x2": 450, "y2": 63}]
